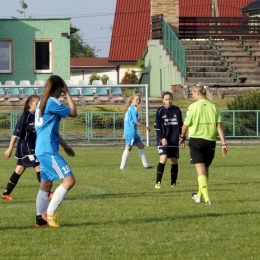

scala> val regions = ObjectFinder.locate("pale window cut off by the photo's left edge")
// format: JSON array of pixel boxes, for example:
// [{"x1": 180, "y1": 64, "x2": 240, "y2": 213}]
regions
[{"x1": 0, "y1": 39, "x2": 13, "y2": 73}]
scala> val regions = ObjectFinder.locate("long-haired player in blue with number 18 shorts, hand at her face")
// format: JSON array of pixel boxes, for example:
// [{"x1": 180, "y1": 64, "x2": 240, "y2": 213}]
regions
[{"x1": 35, "y1": 75, "x2": 77, "y2": 228}]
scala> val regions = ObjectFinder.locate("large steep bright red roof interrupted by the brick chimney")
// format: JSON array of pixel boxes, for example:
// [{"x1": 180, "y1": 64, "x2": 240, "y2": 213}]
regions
[{"x1": 108, "y1": 0, "x2": 254, "y2": 62}]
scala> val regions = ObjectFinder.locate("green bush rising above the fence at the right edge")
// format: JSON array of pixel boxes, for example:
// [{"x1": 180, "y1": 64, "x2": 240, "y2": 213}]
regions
[{"x1": 227, "y1": 90, "x2": 260, "y2": 110}]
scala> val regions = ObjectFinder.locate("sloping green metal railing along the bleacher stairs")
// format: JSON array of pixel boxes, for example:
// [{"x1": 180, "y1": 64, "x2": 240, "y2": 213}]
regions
[{"x1": 163, "y1": 19, "x2": 186, "y2": 77}]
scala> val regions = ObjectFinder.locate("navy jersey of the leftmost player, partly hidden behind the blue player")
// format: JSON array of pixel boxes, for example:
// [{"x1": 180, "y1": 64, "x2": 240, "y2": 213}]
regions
[{"x1": 13, "y1": 110, "x2": 36, "y2": 159}]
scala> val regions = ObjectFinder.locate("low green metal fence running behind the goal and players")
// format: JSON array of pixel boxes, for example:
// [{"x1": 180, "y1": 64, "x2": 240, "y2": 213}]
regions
[{"x1": 0, "y1": 110, "x2": 260, "y2": 145}]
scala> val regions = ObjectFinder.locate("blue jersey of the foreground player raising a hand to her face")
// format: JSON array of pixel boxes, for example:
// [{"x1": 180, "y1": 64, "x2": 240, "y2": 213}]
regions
[{"x1": 35, "y1": 97, "x2": 71, "y2": 156}]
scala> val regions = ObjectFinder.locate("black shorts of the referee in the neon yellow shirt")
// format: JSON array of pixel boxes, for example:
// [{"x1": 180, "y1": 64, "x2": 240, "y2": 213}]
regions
[{"x1": 189, "y1": 138, "x2": 216, "y2": 167}]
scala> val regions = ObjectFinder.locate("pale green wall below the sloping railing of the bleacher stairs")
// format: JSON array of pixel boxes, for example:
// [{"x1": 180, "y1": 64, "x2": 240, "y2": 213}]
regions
[{"x1": 140, "y1": 42, "x2": 182, "y2": 97}]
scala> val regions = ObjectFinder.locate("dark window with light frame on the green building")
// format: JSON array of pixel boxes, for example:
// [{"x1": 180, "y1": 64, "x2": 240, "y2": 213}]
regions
[{"x1": 34, "y1": 40, "x2": 53, "y2": 73}]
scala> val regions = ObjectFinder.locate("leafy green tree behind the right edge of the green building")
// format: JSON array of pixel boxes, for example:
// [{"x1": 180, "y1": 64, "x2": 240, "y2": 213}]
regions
[{"x1": 70, "y1": 29, "x2": 96, "y2": 58}]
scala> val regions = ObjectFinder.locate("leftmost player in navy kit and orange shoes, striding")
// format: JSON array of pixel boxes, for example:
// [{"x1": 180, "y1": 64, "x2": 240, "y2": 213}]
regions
[{"x1": 2, "y1": 95, "x2": 40, "y2": 200}]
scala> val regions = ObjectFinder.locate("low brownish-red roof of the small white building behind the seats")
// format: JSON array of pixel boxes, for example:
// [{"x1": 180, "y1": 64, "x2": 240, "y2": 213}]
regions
[{"x1": 70, "y1": 57, "x2": 117, "y2": 69}]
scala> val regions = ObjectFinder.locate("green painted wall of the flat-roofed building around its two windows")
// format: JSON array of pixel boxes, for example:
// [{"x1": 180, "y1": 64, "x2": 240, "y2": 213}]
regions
[{"x1": 0, "y1": 18, "x2": 70, "y2": 84}]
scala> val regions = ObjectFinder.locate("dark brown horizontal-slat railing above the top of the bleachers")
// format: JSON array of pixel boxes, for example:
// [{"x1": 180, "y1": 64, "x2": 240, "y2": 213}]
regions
[{"x1": 179, "y1": 17, "x2": 260, "y2": 40}]
